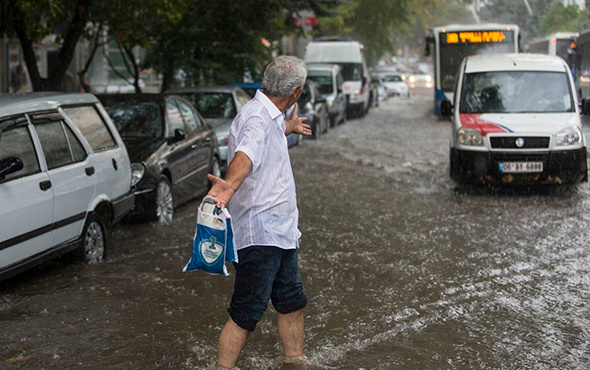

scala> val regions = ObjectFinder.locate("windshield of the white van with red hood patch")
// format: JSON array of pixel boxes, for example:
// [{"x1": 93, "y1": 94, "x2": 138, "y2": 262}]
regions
[{"x1": 460, "y1": 71, "x2": 573, "y2": 113}]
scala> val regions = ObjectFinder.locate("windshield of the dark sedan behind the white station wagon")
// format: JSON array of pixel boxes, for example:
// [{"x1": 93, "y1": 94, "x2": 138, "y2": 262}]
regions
[{"x1": 105, "y1": 102, "x2": 164, "y2": 138}]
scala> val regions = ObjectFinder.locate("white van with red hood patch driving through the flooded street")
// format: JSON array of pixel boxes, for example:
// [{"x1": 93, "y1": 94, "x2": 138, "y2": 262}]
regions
[{"x1": 441, "y1": 54, "x2": 588, "y2": 184}]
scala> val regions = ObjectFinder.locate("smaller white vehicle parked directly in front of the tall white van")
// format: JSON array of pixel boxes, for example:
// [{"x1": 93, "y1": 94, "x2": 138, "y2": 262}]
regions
[{"x1": 307, "y1": 64, "x2": 346, "y2": 127}]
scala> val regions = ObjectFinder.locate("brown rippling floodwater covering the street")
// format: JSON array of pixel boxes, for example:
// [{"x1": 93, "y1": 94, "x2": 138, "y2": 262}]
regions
[{"x1": 0, "y1": 90, "x2": 590, "y2": 370}]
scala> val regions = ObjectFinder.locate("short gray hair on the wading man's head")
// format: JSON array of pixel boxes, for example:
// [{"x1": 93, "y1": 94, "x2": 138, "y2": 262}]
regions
[{"x1": 262, "y1": 55, "x2": 307, "y2": 98}]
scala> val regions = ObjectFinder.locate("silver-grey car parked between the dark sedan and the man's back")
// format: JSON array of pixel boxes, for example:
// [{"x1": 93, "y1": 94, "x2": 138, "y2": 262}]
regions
[{"x1": 167, "y1": 86, "x2": 250, "y2": 172}]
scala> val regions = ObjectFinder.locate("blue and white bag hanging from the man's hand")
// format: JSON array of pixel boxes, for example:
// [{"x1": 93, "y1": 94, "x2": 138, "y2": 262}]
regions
[{"x1": 182, "y1": 196, "x2": 238, "y2": 276}]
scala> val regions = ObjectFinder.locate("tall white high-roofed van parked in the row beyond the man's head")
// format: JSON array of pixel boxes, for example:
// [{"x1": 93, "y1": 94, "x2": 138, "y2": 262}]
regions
[{"x1": 305, "y1": 41, "x2": 371, "y2": 116}]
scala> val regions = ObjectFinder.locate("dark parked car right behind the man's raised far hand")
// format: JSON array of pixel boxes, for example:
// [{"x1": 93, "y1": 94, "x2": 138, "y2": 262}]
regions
[{"x1": 297, "y1": 79, "x2": 330, "y2": 139}]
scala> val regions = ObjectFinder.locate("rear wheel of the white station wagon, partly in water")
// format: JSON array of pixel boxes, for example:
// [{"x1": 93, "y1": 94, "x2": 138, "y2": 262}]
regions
[{"x1": 76, "y1": 213, "x2": 107, "y2": 265}]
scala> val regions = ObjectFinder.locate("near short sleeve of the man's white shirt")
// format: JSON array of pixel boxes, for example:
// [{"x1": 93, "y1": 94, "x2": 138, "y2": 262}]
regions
[{"x1": 235, "y1": 116, "x2": 269, "y2": 169}]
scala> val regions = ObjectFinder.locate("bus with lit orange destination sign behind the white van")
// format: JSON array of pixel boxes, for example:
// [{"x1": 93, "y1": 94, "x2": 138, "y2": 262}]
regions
[{"x1": 426, "y1": 23, "x2": 520, "y2": 117}]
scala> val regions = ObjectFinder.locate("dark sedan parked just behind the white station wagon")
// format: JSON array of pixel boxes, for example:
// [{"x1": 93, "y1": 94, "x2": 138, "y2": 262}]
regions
[{"x1": 98, "y1": 94, "x2": 221, "y2": 223}]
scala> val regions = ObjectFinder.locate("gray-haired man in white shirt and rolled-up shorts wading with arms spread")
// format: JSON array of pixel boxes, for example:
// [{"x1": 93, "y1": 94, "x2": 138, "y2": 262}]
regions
[{"x1": 208, "y1": 56, "x2": 311, "y2": 369}]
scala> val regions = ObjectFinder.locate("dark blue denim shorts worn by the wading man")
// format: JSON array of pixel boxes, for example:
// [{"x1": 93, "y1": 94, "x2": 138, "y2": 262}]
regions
[{"x1": 228, "y1": 246, "x2": 307, "y2": 332}]
